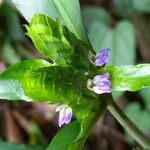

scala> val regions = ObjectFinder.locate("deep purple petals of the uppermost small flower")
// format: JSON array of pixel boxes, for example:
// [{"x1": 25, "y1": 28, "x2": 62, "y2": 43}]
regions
[{"x1": 95, "y1": 48, "x2": 110, "y2": 66}]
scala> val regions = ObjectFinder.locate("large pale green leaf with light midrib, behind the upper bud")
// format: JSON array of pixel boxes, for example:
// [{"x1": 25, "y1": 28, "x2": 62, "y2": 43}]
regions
[{"x1": 9, "y1": 0, "x2": 89, "y2": 44}]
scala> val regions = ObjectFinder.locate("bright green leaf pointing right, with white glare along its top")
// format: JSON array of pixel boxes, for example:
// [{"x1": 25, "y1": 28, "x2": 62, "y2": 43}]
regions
[{"x1": 100, "y1": 64, "x2": 150, "y2": 91}]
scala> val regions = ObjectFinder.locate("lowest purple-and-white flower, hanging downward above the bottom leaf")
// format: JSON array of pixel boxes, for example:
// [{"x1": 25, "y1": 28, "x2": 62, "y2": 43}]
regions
[{"x1": 56, "y1": 105, "x2": 72, "y2": 127}]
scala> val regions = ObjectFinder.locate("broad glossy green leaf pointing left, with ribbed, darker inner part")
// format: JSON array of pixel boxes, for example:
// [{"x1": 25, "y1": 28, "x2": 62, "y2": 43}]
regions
[{"x1": 0, "y1": 60, "x2": 85, "y2": 102}]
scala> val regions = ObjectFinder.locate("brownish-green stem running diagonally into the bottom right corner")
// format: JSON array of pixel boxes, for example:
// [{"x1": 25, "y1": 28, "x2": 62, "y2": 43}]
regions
[{"x1": 107, "y1": 101, "x2": 150, "y2": 149}]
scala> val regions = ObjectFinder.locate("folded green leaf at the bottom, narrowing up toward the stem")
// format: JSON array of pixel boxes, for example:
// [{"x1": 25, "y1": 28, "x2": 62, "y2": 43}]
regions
[{"x1": 48, "y1": 95, "x2": 109, "y2": 150}]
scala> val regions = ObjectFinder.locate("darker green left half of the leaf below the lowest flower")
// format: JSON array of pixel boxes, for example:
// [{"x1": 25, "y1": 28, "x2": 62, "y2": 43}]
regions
[{"x1": 47, "y1": 121, "x2": 80, "y2": 150}]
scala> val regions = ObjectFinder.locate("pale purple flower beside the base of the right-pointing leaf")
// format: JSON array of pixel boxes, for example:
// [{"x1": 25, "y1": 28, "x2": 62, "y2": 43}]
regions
[{"x1": 87, "y1": 73, "x2": 111, "y2": 94}]
